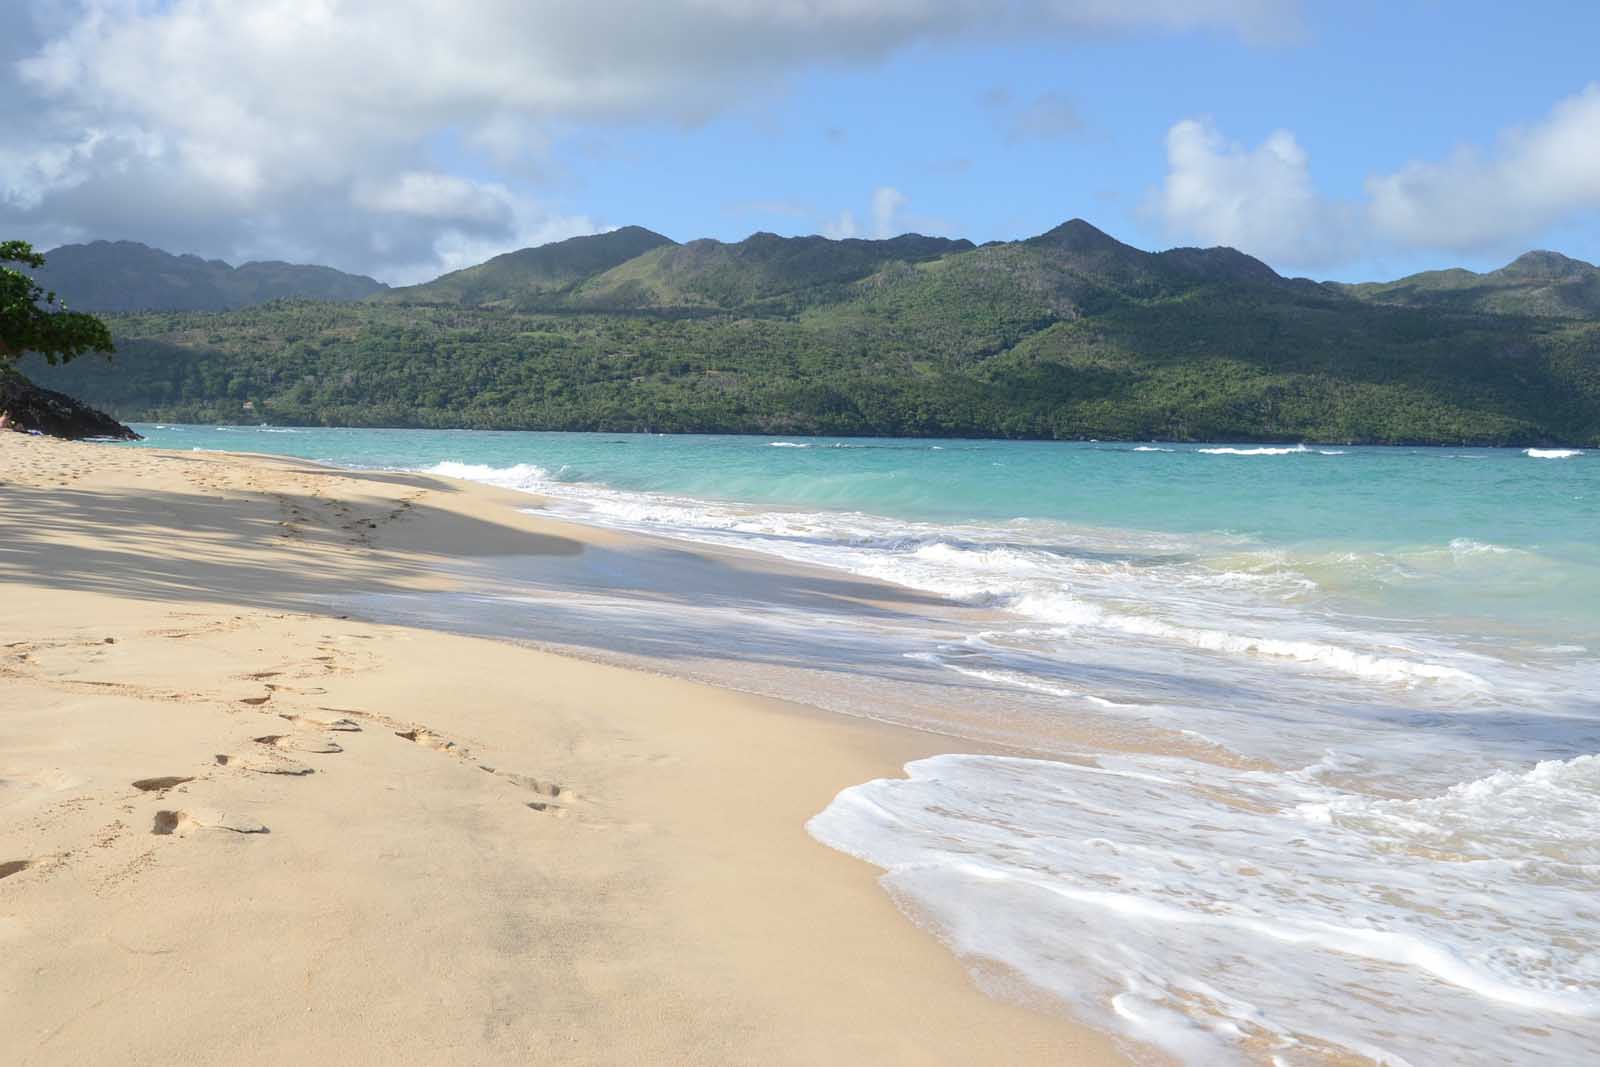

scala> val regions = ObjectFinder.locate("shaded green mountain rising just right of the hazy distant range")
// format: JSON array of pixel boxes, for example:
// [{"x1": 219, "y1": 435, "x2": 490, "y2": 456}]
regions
[{"x1": 382, "y1": 226, "x2": 674, "y2": 307}]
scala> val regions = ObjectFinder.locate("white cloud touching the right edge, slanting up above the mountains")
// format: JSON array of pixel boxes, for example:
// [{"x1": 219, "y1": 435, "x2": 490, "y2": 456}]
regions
[{"x1": 1366, "y1": 83, "x2": 1600, "y2": 251}]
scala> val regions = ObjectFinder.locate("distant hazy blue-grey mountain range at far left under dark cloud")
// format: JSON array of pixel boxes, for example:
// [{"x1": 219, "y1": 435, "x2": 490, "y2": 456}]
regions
[{"x1": 34, "y1": 242, "x2": 387, "y2": 312}]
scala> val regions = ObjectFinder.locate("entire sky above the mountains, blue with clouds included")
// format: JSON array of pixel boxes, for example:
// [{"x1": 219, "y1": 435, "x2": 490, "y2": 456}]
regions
[{"x1": 9, "y1": 0, "x2": 1600, "y2": 282}]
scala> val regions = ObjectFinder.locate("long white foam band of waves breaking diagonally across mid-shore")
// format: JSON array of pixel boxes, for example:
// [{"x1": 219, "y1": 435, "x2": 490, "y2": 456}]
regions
[{"x1": 416, "y1": 462, "x2": 1510, "y2": 691}]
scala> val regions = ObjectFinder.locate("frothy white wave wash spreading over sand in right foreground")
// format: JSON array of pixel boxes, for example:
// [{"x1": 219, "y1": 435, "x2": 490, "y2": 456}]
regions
[{"x1": 808, "y1": 755, "x2": 1600, "y2": 1065}]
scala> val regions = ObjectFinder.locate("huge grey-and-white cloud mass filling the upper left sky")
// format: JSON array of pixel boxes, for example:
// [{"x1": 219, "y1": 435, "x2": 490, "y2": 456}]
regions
[{"x1": 0, "y1": 0, "x2": 1298, "y2": 280}]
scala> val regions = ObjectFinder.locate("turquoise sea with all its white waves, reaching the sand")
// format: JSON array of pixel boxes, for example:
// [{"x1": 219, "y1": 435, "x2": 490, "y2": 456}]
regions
[{"x1": 124, "y1": 426, "x2": 1600, "y2": 1064}]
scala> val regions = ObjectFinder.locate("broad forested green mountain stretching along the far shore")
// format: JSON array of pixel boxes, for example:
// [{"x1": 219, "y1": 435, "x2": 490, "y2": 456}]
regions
[{"x1": 21, "y1": 219, "x2": 1600, "y2": 446}]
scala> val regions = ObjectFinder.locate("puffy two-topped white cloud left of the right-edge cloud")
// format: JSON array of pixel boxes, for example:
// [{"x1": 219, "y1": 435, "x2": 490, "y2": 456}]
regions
[{"x1": 1157, "y1": 118, "x2": 1354, "y2": 267}]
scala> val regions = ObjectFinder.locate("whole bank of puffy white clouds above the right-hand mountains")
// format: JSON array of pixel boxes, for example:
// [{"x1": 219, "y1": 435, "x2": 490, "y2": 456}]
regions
[{"x1": 1152, "y1": 83, "x2": 1600, "y2": 267}]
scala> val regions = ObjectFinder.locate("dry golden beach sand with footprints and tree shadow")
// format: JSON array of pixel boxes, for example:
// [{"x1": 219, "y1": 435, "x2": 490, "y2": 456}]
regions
[{"x1": 0, "y1": 434, "x2": 1122, "y2": 1064}]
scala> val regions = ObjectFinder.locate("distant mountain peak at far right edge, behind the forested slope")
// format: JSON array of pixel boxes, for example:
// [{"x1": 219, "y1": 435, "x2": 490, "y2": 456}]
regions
[{"x1": 1339, "y1": 251, "x2": 1600, "y2": 318}]
